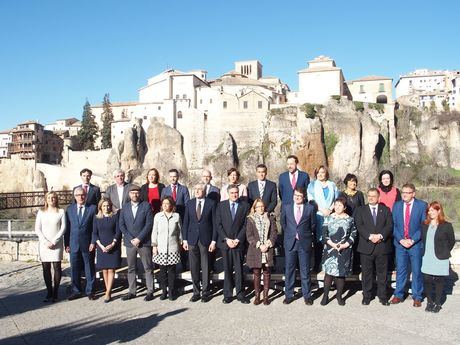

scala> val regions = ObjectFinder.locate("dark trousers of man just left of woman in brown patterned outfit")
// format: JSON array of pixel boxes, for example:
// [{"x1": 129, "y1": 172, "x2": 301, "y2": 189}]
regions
[{"x1": 222, "y1": 249, "x2": 243, "y2": 298}]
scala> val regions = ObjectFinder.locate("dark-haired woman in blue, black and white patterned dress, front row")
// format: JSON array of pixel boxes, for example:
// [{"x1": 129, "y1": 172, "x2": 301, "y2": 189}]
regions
[{"x1": 321, "y1": 197, "x2": 357, "y2": 306}]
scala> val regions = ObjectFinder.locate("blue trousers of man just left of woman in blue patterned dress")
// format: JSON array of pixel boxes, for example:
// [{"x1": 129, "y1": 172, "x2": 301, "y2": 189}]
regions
[{"x1": 284, "y1": 241, "x2": 311, "y2": 298}]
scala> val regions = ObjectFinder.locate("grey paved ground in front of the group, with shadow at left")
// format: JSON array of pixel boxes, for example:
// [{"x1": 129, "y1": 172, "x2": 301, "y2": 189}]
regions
[{"x1": 0, "y1": 262, "x2": 460, "y2": 345}]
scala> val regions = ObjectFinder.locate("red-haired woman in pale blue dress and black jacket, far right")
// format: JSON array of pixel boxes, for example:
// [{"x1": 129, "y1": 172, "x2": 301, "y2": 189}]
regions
[{"x1": 422, "y1": 201, "x2": 455, "y2": 313}]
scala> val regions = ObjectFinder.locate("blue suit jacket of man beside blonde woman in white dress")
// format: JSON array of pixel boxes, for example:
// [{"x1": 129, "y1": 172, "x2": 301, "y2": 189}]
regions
[{"x1": 64, "y1": 203, "x2": 96, "y2": 253}]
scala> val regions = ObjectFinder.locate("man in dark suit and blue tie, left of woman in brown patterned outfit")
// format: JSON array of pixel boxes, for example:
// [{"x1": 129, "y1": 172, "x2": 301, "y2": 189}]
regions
[{"x1": 216, "y1": 184, "x2": 250, "y2": 304}]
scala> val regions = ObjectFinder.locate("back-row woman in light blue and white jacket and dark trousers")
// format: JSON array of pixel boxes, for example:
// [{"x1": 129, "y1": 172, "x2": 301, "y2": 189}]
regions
[{"x1": 307, "y1": 165, "x2": 339, "y2": 272}]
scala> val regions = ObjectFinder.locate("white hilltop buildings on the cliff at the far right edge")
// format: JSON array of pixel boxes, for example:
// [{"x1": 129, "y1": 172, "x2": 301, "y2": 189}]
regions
[{"x1": 395, "y1": 69, "x2": 460, "y2": 110}]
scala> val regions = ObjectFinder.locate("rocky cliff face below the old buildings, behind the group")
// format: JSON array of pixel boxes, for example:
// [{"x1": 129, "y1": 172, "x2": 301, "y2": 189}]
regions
[{"x1": 0, "y1": 99, "x2": 460, "y2": 192}]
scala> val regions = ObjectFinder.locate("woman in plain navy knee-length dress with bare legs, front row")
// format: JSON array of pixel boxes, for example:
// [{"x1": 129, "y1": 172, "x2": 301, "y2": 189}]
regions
[{"x1": 93, "y1": 198, "x2": 121, "y2": 303}]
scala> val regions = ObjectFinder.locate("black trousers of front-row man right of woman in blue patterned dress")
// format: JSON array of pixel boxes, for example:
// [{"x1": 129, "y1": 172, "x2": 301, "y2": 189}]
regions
[{"x1": 360, "y1": 253, "x2": 390, "y2": 301}]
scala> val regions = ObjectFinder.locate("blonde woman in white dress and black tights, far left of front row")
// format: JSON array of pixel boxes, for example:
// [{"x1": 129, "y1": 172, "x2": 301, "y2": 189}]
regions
[{"x1": 35, "y1": 192, "x2": 65, "y2": 302}]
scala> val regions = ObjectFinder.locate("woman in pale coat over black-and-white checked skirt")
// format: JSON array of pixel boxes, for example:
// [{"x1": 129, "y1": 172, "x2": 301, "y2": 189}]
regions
[{"x1": 152, "y1": 196, "x2": 182, "y2": 301}]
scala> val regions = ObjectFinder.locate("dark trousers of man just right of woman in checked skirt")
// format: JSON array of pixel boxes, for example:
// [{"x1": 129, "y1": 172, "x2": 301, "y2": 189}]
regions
[{"x1": 188, "y1": 241, "x2": 209, "y2": 295}]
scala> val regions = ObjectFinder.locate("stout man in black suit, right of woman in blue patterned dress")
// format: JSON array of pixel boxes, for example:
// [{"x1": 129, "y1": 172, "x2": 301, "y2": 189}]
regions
[{"x1": 354, "y1": 188, "x2": 393, "y2": 306}]
